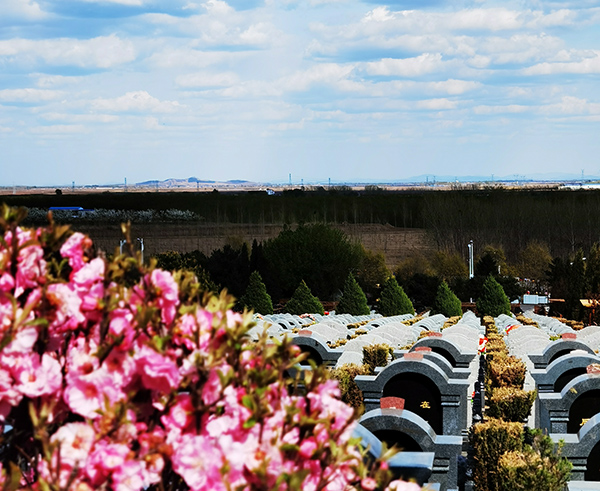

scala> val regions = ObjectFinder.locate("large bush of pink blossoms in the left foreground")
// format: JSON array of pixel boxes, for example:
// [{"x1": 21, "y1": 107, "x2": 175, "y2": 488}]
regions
[{"x1": 0, "y1": 210, "x2": 422, "y2": 491}]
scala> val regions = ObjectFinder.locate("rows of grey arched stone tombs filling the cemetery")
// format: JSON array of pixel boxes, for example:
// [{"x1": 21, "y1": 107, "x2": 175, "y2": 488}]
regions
[{"x1": 252, "y1": 311, "x2": 600, "y2": 490}]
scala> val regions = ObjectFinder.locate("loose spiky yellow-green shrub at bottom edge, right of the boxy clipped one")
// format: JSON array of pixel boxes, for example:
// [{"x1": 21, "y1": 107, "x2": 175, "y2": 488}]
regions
[{"x1": 498, "y1": 430, "x2": 573, "y2": 491}]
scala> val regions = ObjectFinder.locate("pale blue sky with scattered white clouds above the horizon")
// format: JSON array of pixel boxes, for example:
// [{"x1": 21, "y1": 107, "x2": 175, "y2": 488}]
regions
[{"x1": 0, "y1": 0, "x2": 600, "y2": 186}]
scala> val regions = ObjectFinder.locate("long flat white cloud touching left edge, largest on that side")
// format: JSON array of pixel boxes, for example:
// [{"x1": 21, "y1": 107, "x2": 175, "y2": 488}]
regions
[{"x1": 0, "y1": 34, "x2": 135, "y2": 68}]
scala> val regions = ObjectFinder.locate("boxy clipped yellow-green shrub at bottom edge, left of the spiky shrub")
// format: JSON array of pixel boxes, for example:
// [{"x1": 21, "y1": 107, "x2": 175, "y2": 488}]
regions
[{"x1": 469, "y1": 419, "x2": 523, "y2": 491}]
